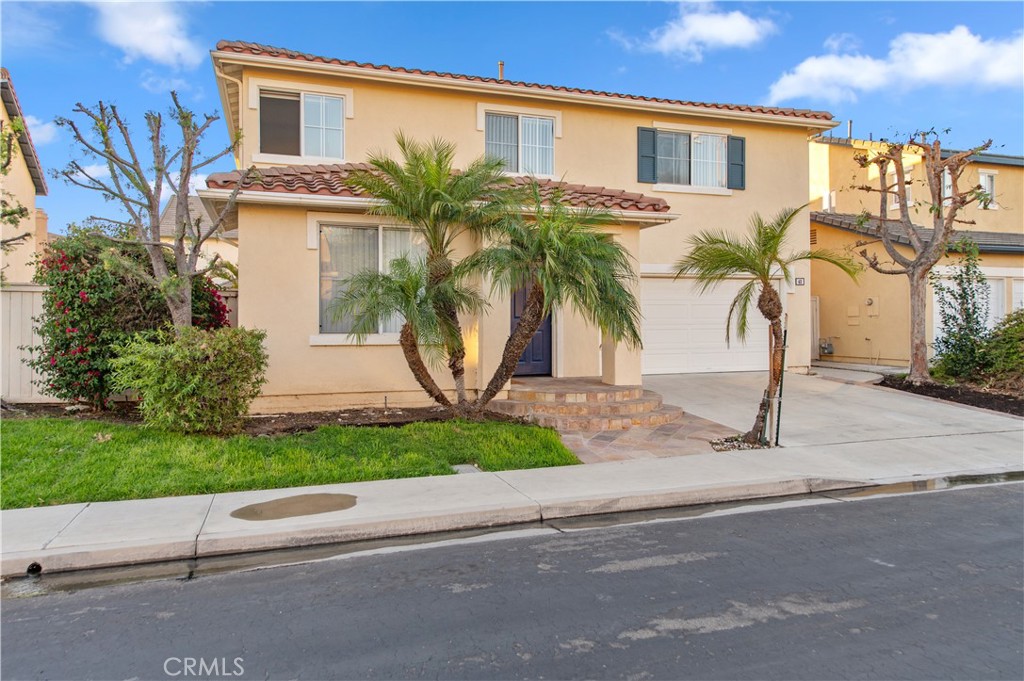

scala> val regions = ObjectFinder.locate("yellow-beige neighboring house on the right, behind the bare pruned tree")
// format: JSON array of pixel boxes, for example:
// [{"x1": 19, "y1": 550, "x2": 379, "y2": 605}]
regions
[{"x1": 810, "y1": 137, "x2": 1024, "y2": 366}]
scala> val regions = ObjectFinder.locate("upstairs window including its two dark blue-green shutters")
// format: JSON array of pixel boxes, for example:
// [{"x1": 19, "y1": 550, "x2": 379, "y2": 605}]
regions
[{"x1": 637, "y1": 128, "x2": 746, "y2": 189}]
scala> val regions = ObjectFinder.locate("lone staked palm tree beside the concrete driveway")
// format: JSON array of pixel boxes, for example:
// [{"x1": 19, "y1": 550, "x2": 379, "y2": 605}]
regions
[{"x1": 675, "y1": 206, "x2": 860, "y2": 444}]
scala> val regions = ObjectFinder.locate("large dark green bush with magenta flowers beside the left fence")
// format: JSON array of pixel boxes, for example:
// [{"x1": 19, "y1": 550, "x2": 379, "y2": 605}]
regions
[{"x1": 28, "y1": 230, "x2": 227, "y2": 409}]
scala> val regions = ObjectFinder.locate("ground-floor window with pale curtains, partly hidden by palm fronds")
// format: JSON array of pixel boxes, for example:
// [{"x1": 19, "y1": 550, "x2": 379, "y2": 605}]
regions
[{"x1": 319, "y1": 224, "x2": 425, "y2": 334}]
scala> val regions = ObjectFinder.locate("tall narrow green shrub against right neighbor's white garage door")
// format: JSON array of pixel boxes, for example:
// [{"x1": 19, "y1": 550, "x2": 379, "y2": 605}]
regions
[{"x1": 932, "y1": 240, "x2": 988, "y2": 378}]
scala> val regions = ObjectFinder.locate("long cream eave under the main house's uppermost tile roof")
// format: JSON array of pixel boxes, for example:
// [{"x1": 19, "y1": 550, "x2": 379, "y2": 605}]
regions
[{"x1": 211, "y1": 50, "x2": 840, "y2": 130}]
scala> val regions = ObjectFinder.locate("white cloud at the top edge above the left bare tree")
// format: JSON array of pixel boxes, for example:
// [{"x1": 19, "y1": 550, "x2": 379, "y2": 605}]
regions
[{"x1": 92, "y1": 2, "x2": 204, "y2": 69}]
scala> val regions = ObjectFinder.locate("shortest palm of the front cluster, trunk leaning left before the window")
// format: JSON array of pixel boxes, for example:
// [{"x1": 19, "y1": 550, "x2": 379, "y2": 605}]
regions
[{"x1": 332, "y1": 256, "x2": 486, "y2": 409}]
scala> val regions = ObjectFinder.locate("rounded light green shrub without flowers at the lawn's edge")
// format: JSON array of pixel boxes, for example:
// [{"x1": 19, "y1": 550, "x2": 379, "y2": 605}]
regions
[{"x1": 112, "y1": 328, "x2": 267, "y2": 433}]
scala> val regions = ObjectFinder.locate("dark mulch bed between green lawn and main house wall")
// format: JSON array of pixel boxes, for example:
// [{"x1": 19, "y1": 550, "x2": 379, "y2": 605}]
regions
[{"x1": 3, "y1": 402, "x2": 525, "y2": 435}]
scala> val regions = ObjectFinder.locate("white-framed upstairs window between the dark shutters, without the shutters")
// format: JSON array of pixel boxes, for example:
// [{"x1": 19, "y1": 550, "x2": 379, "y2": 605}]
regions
[{"x1": 656, "y1": 130, "x2": 729, "y2": 188}]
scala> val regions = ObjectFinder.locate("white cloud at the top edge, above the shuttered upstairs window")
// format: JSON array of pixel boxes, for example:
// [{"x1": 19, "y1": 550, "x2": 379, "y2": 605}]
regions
[{"x1": 609, "y1": 3, "x2": 776, "y2": 61}]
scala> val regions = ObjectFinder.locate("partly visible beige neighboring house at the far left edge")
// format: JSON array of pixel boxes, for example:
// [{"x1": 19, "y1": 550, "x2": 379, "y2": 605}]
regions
[{"x1": 0, "y1": 69, "x2": 47, "y2": 284}]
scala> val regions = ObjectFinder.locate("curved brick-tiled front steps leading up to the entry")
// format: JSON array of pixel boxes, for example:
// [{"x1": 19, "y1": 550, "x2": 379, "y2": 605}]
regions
[{"x1": 490, "y1": 377, "x2": 683, "y2": 431}]
